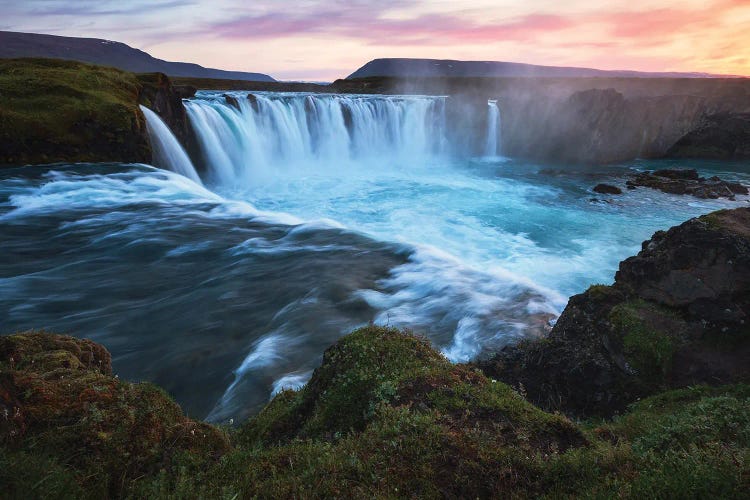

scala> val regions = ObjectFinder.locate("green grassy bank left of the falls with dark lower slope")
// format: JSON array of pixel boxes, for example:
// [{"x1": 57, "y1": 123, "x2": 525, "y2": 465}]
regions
[{"x1": 0, "y1": 59, "x2": 156, "y2": 165}]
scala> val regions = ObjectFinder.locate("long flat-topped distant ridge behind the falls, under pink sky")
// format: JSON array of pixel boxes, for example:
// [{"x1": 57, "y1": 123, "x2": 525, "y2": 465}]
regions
[{"x1": 347, "y1": 58, "x2": 728, "y2": 79}]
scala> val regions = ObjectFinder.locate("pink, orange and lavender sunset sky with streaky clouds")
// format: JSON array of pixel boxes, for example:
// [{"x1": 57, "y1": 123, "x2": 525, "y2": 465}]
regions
[{"x1": 0, "y1": 0, "x2": 750, "y2": 81}]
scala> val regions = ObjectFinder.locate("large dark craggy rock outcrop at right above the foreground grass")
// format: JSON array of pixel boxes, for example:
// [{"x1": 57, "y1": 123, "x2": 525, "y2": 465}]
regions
[{"x1": 479, "y1": 208, "x2": 750, "y2": 415}]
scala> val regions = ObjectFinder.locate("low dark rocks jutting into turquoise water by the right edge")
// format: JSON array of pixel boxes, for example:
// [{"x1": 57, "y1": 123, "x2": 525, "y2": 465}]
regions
[{"x1": 627, "y1": 168, "x2": 748, "y2": 200}]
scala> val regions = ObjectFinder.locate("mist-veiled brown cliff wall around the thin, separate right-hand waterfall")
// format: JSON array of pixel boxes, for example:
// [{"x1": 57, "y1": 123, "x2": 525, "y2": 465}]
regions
[{"x1": 332, "y1": 77, "x2": 750, "y2": 163}]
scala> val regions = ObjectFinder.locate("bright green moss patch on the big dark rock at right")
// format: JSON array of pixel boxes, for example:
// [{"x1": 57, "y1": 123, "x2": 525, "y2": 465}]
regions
[{"x1": 609, "y1": 300, "x2": 675, "y2": 383}]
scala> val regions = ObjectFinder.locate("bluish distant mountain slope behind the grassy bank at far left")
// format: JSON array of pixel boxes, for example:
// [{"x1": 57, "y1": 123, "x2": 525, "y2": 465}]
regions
[{"x1": 0, "y1": 31, "x2": 276, "y2": 82}]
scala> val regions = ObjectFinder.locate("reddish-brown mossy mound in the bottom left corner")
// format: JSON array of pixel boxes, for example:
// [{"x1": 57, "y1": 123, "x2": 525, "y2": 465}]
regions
[{"x1": 0, "y1": 332, "x2": 229, "y2": 498}]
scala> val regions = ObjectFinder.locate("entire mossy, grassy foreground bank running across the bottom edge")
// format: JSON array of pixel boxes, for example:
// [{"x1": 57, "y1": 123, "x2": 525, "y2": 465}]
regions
[{"x1": 0, "y1": 327, "x2": 750, "y2": 498}]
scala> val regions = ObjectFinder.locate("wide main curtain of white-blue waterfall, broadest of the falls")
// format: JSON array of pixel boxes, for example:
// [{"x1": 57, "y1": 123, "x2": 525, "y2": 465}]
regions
[{"x1": 185, "y1": 92, "x2": 446, "y2": 185}]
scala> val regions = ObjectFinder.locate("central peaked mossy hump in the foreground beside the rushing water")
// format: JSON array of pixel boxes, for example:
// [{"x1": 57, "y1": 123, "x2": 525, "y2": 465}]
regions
[{"x1": 242, "y1": 326, "x2": 584, "y2": 449}]
